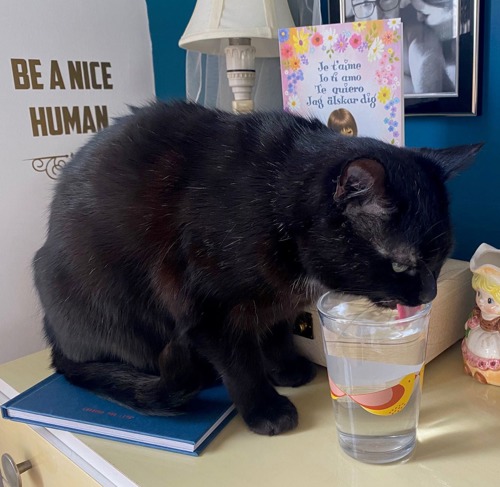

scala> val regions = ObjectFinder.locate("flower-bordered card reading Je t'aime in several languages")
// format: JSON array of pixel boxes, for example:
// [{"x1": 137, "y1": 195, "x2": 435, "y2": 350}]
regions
[{"x1": 278, "y1": 19, "x2": 404, "y2": 146}]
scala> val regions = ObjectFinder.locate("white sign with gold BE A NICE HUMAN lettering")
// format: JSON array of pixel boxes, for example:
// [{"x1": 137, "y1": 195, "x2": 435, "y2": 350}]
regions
[{"x1": 0, "y1": 0, "x2": 154, "y2": 362}]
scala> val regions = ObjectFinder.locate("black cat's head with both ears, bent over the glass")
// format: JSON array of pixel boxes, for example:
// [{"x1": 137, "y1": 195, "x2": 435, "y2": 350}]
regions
[{"x1": 298, "y1": 139, "x2": 481, "y2": 307}]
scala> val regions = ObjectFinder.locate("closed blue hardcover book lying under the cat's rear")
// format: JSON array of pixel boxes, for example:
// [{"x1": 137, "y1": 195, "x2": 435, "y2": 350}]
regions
[{"x1": 2, "y1": 373, "x2": 236, "y2": 455}]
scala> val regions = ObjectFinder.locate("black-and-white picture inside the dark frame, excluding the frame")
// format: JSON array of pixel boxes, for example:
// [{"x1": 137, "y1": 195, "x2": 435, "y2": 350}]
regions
[{"x1": 346, "y1": 0, "x2": 456, "y2": 96}]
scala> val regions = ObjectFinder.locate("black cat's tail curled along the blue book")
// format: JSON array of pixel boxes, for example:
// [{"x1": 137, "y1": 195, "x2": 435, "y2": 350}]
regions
[{"x1": 52, "y1": 349, "x2": 199, "y2": 416}]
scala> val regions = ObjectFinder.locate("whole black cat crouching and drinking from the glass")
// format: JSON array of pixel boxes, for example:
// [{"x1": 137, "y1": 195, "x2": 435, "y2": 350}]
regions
[{"x1": 34, "y1": 102, "x2": 479, "y2": 435}]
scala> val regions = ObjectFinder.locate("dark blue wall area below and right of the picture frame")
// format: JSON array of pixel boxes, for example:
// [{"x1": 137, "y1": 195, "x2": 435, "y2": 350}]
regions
[{"x1": 405, "y1": 0, "x2": 500, "y2": 260}]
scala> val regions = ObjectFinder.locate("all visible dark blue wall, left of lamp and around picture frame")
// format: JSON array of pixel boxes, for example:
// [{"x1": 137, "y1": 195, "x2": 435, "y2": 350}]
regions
[{"x1": 147, "y1": 0, "x2": 500, "y2": 260}]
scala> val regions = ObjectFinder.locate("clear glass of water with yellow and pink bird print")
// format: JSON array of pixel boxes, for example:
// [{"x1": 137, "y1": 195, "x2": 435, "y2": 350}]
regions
[{"x1": 318, "y1": 292, "x2": 431, "y2": 463}]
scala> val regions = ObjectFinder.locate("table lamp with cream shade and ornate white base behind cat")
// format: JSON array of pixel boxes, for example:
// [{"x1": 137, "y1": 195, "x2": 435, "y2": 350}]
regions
[{"x1": 179, "y1": 0, "x2": 294, "y2": 113}]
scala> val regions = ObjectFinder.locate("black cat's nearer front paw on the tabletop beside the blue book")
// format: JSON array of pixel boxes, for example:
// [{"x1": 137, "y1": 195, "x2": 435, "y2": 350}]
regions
[{"x1": 243, "y1": 394, "x2": 299, "y2": 436}]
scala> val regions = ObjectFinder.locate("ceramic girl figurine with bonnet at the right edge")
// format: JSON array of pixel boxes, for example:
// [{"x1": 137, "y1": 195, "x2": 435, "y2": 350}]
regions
[{"x1": 462, "y1": 243, "x2": 500, "y2": 386}]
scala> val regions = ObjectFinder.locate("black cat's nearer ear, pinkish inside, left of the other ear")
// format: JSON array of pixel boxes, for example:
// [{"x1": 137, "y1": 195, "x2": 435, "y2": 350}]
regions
[{"x1": 333, "y1": 159, "x2": 386, "y2": 214}]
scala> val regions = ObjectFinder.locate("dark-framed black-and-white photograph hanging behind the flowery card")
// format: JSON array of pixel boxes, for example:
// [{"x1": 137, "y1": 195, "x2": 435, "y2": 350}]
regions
[{"x1": 329, "y1": 0, "x2": 480, "y2": 115}]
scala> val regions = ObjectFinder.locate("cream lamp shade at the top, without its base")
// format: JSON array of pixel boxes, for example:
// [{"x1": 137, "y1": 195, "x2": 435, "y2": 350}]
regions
[{"x1": 179, "y1": 0, "x2": 294, "y2": 57}]
